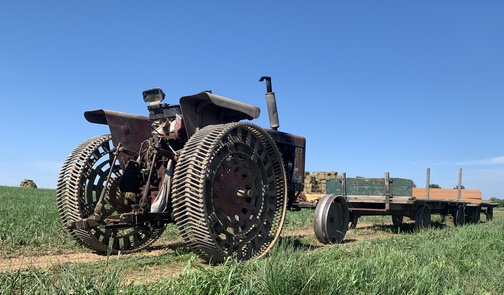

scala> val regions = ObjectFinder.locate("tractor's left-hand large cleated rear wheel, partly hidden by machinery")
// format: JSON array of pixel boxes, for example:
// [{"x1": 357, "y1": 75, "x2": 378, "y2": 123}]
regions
[{"x1": 56, "y1": 135, "x2": 164, "y2": 253}]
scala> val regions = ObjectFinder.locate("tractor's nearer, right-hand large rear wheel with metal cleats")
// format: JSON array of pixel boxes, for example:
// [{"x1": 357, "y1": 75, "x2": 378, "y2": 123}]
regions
[{"x1": 172, "y1": 122, "x2": 287, "y2": 262}]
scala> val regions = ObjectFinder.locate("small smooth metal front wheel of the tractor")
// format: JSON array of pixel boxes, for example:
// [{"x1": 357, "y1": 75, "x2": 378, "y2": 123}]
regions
[{"x1": 314, "y1": 195, "x2": 349, "y2": 244}]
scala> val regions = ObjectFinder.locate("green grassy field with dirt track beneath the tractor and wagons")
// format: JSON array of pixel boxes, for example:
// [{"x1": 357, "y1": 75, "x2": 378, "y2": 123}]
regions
[{"x1": 0, "y1": 187, "x2": 504, "y2": 294}]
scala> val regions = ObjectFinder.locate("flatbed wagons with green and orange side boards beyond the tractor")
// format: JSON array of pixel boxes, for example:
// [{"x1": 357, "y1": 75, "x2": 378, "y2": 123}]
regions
[{"x1": 327, "y1": 169, "x2": 497, "y2": 228}]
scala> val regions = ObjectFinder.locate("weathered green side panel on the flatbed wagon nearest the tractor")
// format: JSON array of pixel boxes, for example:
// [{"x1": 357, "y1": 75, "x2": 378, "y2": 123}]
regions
[{"x1": 326, "y1": 177, "x2": 413, "y2": 196}]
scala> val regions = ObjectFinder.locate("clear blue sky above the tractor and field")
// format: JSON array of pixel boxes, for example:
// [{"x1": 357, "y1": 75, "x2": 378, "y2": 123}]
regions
[{"x1": 0, "y1": 0, "x2": 504, "y2": 199}]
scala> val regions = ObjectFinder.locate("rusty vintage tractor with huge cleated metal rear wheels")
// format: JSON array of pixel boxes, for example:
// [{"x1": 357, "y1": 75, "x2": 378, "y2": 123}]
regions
[{"x1": 57, "y1": 77, "x2": 306, "y2": 262}]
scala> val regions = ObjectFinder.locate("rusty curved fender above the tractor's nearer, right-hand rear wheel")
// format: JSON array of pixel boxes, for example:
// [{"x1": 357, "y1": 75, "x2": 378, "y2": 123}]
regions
[{"x1": 180, "y1": 92, "x2": 261, "y2": 138}]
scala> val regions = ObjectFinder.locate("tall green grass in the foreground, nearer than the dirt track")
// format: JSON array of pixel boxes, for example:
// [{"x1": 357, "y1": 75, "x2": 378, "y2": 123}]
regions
[{"x1": 0, "y1": 215, "x2": 504, "y2": 295}]
